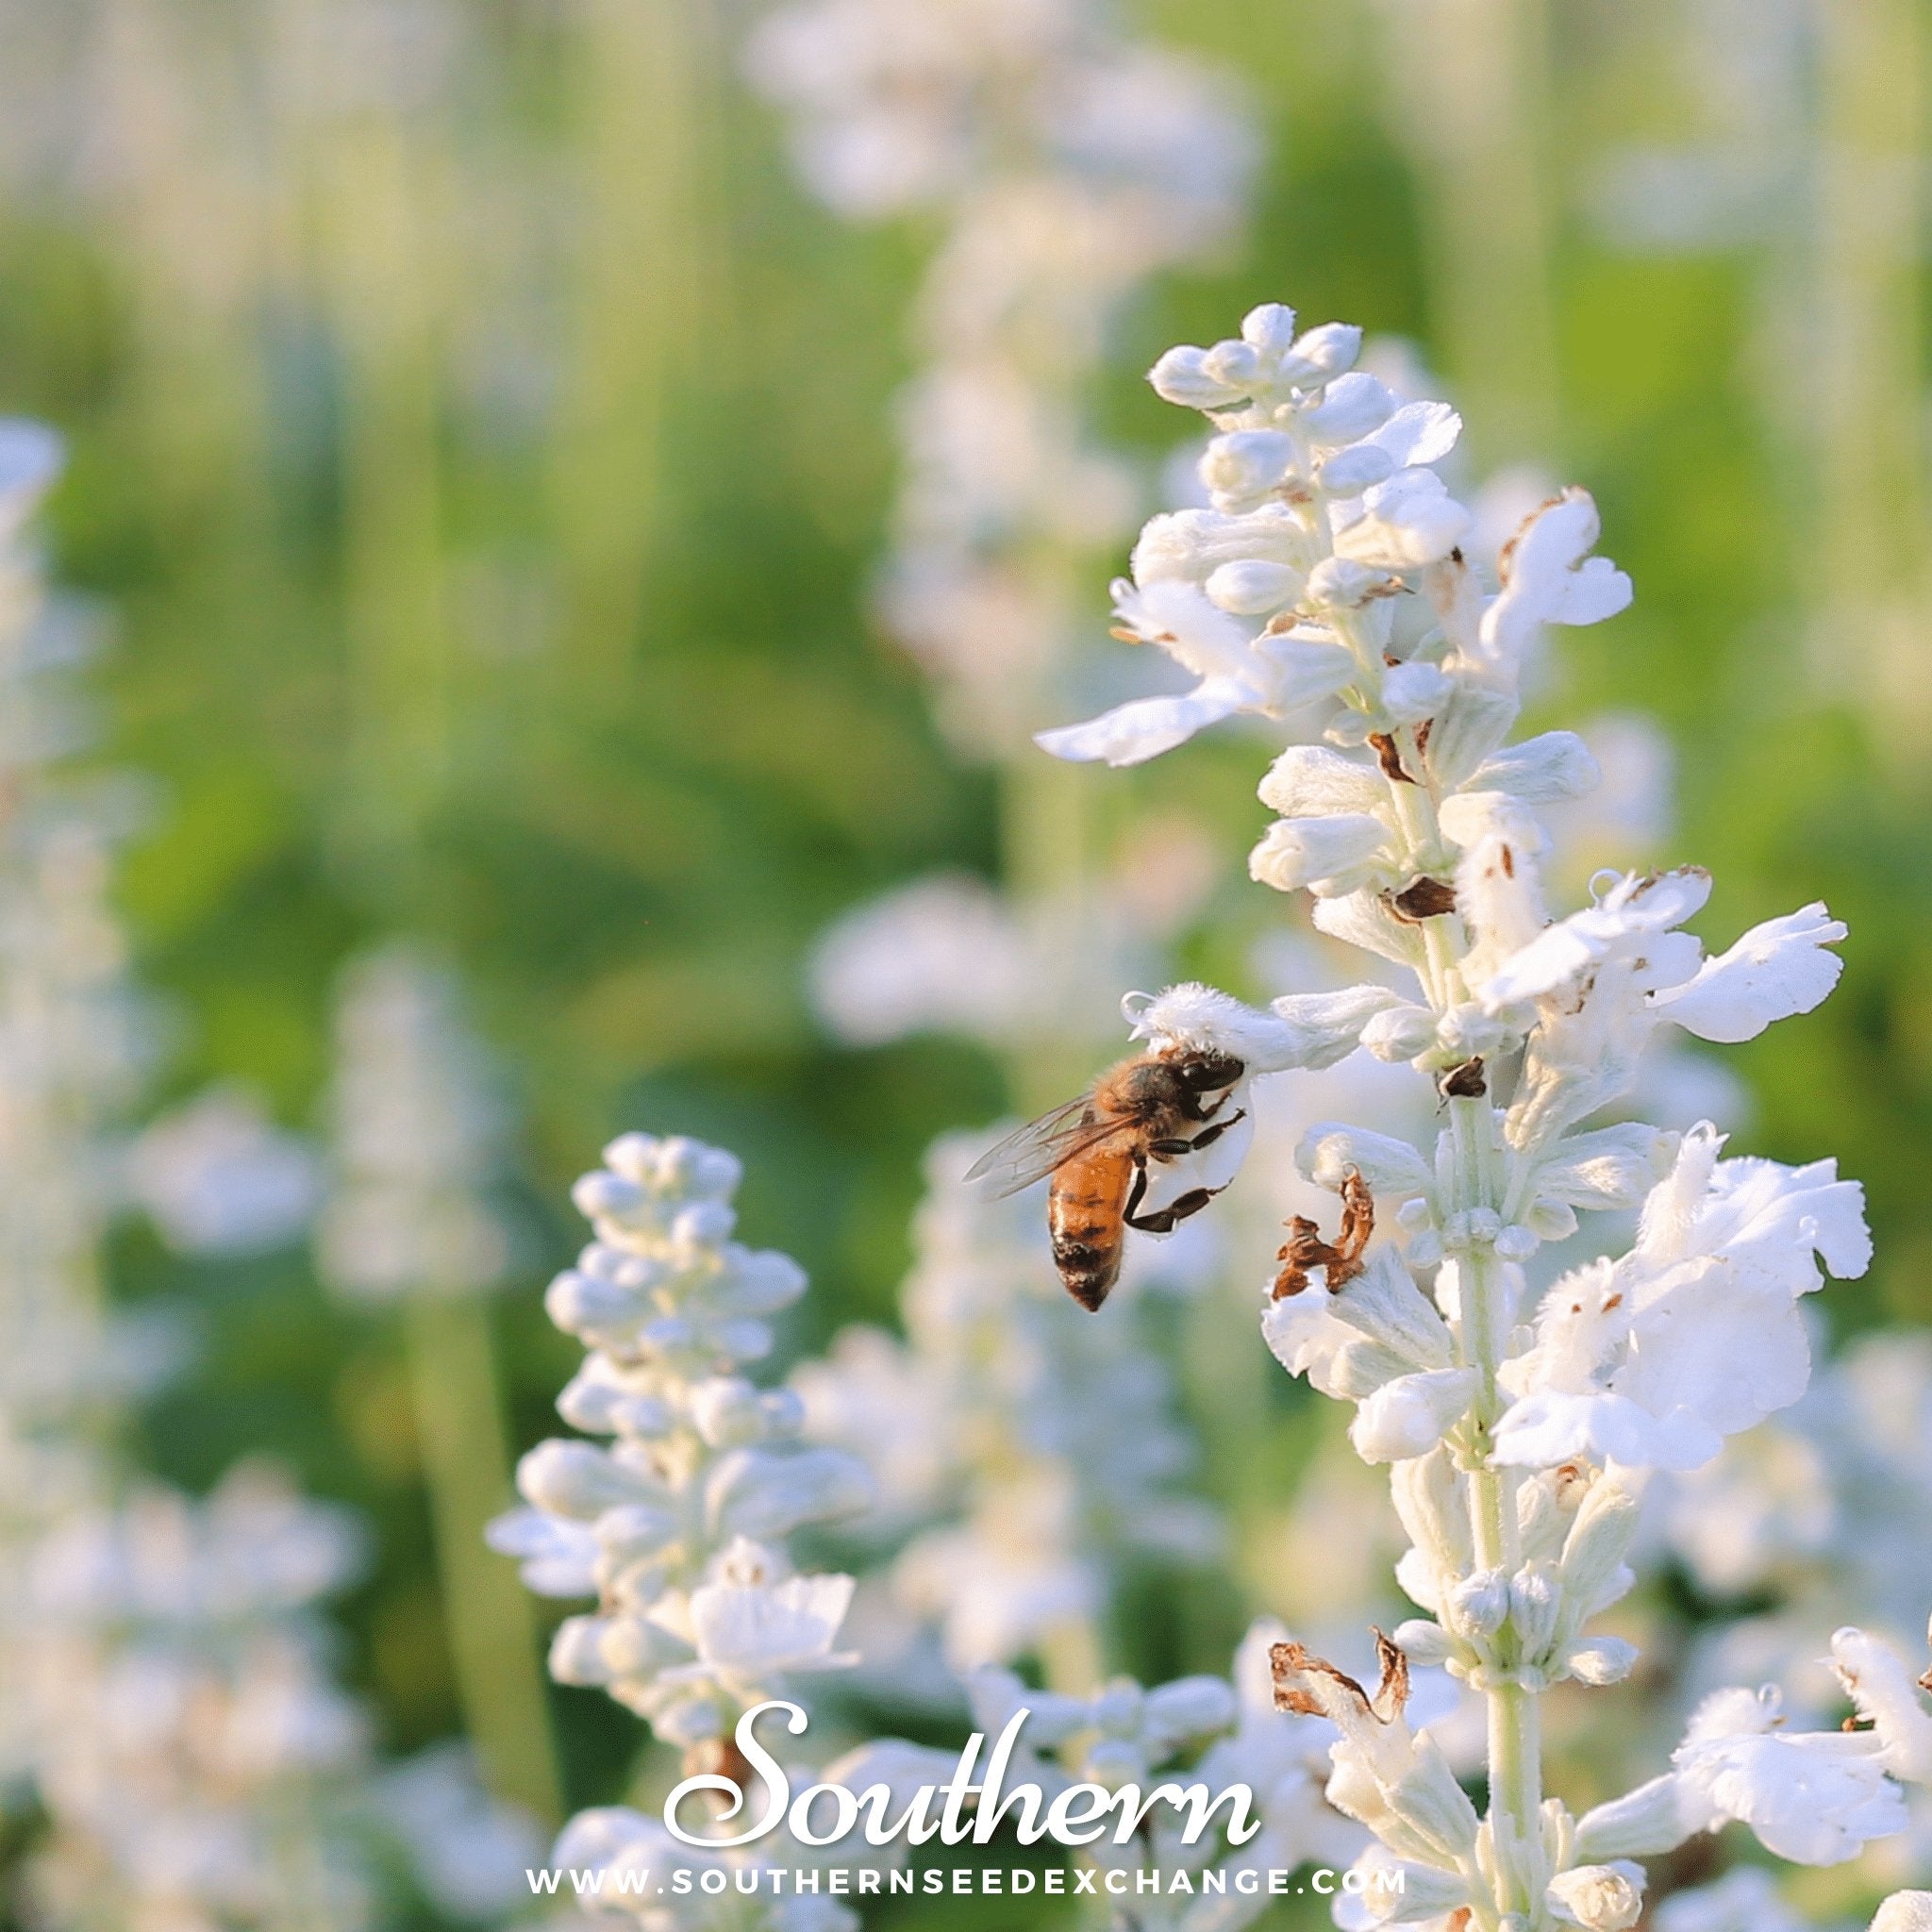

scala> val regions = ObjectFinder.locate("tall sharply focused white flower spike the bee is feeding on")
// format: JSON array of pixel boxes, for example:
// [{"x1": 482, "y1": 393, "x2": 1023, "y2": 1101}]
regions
[{"x1": 1041, "y1": 293, "x2": 1885, "y2": 1932}]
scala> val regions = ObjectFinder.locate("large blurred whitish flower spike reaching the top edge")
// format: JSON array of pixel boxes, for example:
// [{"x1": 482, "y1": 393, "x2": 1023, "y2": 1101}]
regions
[{"x1": 748, "y1": 0, "x2": 1252, "y2": 754}]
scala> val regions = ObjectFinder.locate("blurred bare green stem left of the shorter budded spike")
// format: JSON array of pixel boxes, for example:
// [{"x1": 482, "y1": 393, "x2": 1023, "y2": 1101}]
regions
[{"x1": 408, "y1": 1292, "x2": 562, "y2": 1824}]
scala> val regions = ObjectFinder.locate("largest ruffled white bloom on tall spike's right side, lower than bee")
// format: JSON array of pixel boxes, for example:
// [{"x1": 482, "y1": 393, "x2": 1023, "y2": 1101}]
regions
[{"x1": 1495, "y1": 1126, "x2": 1870, "y2": 1468}]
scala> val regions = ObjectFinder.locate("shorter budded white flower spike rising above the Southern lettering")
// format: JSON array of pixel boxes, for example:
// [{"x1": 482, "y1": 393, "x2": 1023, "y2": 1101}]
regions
[{"x1": 491, "y1": 1134, "x2": 872, "y2": 1753}]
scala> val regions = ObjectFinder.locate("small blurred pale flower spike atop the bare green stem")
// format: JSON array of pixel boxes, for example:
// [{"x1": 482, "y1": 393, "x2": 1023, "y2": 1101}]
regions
[{"x1": 319, "y1": 944, "x2": 510, "y2": 1302}]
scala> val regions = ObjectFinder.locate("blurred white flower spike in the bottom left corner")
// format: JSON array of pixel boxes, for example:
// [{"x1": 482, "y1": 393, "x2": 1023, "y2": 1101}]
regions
[{"x1": 22, "y1": 1468, "x2": 369, "y2": 1932}]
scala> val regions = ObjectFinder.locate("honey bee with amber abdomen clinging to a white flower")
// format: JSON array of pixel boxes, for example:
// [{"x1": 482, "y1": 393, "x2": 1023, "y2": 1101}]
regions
[{"x1": 966, "y1": 1045, "x2": 1248, "y2": 1307}]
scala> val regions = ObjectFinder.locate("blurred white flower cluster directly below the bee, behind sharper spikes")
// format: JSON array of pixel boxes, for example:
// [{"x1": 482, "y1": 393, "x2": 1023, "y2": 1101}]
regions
[{"x1": 792, "y1": 1136, "x2": 1217, "y2": 1667}]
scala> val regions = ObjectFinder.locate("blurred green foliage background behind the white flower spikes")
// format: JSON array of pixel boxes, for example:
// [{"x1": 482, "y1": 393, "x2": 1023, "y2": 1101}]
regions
[{"x1": 0, "y1": 0, "x2": 1932, "y2": 1901}]
